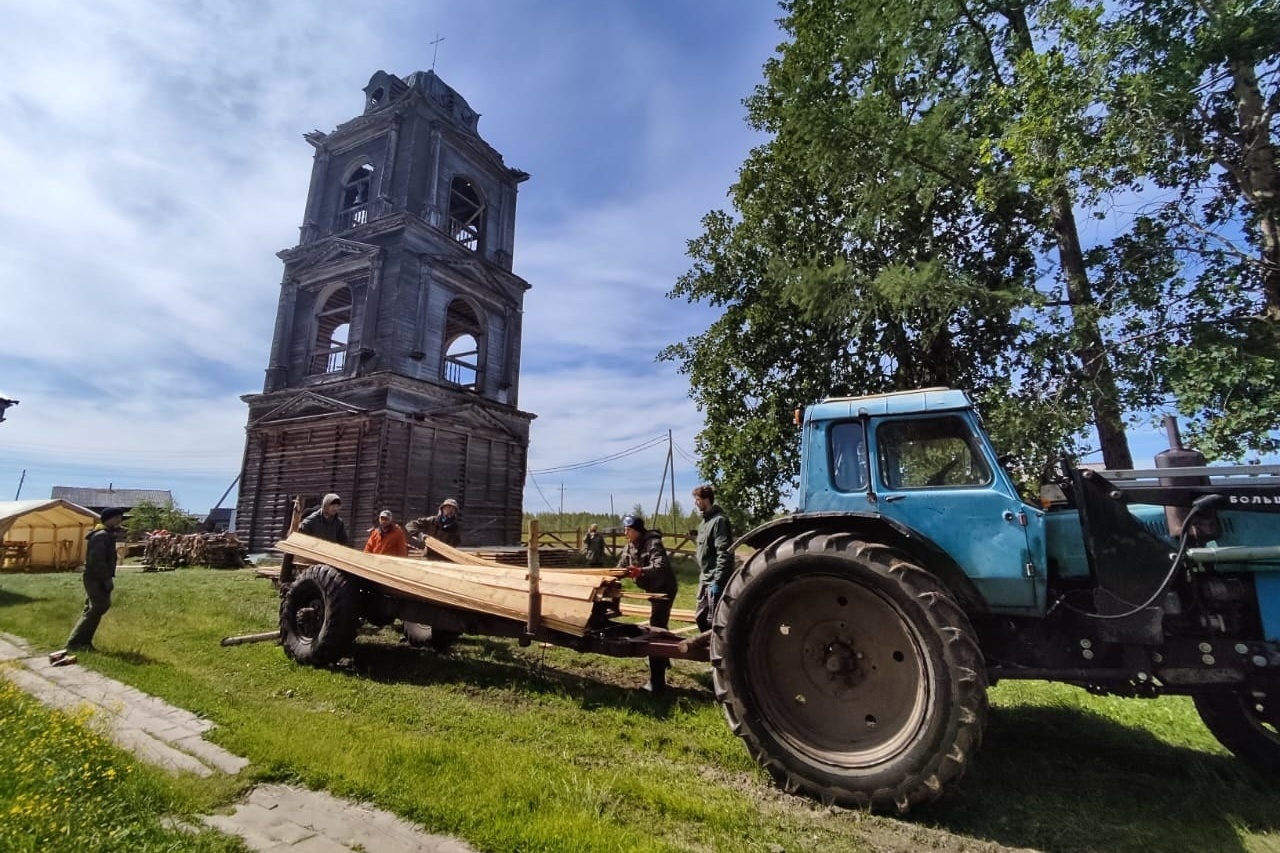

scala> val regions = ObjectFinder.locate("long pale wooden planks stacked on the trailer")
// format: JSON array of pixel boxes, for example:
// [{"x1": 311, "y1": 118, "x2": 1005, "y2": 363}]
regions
[{"x1": 276, "y1": 533, "x2": 622, "y2": 637}]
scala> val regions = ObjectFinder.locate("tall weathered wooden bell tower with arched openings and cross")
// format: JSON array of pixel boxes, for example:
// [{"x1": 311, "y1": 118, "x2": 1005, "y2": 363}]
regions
[{"x1": 237, "y1": 72, "x2": 534, "y2": 551}]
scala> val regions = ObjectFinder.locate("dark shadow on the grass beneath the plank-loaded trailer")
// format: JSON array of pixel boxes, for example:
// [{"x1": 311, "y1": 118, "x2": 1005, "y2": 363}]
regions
[{"x1": 339, "y1": 637, "x2": 710, "y2": 720}]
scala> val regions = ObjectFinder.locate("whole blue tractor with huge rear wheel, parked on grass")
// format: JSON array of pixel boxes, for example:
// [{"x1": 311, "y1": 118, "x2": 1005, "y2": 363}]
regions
[{"x1": 710, "y1": 388, "x2": 1280, "y2": 812}]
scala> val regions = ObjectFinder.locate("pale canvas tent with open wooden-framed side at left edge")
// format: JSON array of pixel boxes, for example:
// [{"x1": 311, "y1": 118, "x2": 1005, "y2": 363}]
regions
[{"x1": 0, "y1": 498, "x2": 97, "y2": 570}]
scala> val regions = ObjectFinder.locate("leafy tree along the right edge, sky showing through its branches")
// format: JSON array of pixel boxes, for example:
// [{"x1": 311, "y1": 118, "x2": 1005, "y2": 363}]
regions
[{"x1": 1070, "y1": 0, "x2": 1280, "y2": 457}]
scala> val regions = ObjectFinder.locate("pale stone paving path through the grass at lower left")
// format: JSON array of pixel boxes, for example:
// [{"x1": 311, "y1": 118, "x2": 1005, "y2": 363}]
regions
[{"x1": 0, "y1": 634, "x2": 474, "y2": 853}]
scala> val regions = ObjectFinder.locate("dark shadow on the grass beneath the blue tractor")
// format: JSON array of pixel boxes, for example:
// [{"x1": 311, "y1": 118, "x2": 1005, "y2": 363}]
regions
[{"x1": 911, "y1": 707, "x2": 1280, "y2": 853}]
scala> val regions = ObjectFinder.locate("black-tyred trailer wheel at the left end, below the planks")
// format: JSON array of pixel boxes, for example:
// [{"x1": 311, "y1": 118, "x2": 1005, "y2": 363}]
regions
[{"x1": 280, "y1": 566, "x2": 360, "y2": 666}]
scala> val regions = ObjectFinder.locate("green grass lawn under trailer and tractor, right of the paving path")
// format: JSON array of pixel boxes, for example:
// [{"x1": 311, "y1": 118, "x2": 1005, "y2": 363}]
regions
[{"x1": 0, "y1": 565, "x2": 1280, "y2": 853}]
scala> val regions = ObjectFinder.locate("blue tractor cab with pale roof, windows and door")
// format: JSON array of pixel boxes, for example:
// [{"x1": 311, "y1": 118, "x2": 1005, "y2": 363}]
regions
[{"x1": 800, "y1": 388, "x2": 1046, "y2": 615}]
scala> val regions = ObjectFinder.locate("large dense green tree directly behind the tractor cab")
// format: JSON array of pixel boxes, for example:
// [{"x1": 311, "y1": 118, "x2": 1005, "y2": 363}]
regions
[{"x1": 663, "y1": 3, "x2": 1044, "y2": 521}]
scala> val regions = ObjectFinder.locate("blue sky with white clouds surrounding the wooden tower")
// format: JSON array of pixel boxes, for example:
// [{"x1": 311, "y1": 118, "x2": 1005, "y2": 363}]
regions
[{"x1": 0, "y1": 0, "x2": 1223, "y2": 522}]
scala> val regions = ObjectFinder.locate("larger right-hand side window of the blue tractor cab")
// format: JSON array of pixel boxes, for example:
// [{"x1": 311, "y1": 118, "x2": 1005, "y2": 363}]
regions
[{"x1": 876, "y1": 418, "x2": 991, "y2": 489}]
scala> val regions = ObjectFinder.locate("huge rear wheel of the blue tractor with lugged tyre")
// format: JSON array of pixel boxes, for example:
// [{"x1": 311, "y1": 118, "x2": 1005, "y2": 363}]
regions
[{"x1": 712, "y1": 533, "x2": 987, "y2": 812}]
